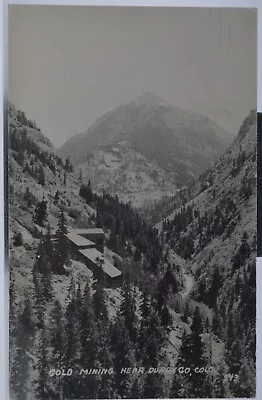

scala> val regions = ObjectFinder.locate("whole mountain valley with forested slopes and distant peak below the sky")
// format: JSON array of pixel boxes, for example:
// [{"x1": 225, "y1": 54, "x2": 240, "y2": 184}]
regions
[{"x1": 9, "y1": 101, "x2": 256, "y2": 400}]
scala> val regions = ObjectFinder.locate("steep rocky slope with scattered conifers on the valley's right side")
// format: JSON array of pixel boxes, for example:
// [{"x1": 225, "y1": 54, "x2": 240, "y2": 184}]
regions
[{"x1": 156, "y1": 110, "x2": 256, "y2": 397}]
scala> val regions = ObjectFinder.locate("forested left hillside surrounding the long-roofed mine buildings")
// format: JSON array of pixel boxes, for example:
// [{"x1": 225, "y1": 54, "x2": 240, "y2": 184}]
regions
[{"x1": 8, "y1": 107, "x2": 183, "y2": 400}]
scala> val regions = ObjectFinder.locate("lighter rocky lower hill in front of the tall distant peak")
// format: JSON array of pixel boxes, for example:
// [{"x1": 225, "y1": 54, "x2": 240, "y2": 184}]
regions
[{"x1": 76, "y1": 142, "x2": 176, "y2": 208}]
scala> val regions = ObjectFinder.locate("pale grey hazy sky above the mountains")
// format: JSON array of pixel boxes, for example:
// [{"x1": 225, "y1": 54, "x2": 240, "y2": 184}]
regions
[{"x1": 9, "y1": 5, "x2": 257, "y2": 146}]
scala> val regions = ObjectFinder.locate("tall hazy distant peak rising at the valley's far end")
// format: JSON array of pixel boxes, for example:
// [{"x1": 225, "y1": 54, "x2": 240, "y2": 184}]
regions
[{"x1": 59, "y1": 93, "x2": 232, "y2": 202}]
